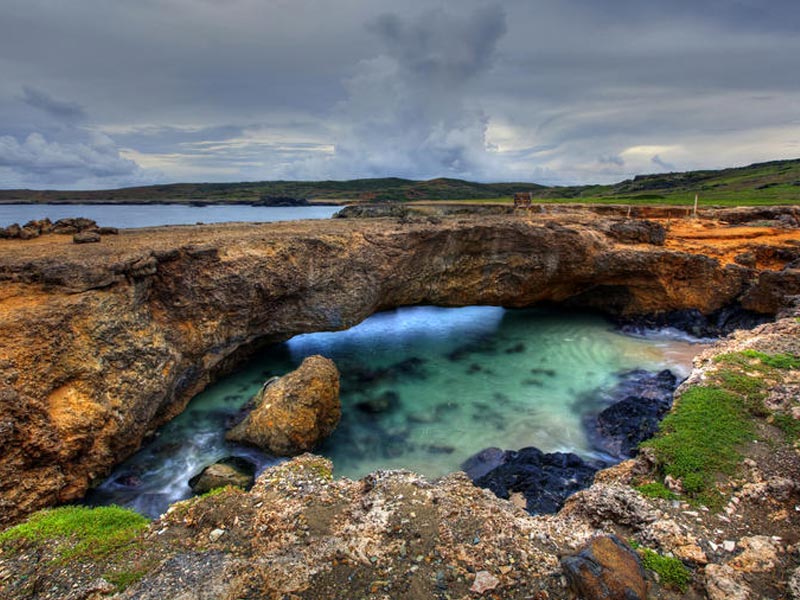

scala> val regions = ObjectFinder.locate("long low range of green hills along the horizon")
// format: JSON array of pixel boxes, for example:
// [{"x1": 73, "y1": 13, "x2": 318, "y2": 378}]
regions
[{"x1": 0, "y1": 159, "x2": 800, "y2": 205}]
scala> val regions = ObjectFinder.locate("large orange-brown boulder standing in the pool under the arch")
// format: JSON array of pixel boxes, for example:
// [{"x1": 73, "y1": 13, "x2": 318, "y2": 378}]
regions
[{"x1": 226, "y1": 356, "x2": 342, "y2": 456}]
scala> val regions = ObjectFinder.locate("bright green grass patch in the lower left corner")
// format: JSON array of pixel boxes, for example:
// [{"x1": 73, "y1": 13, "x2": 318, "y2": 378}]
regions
[{"x1": 0, "y1": 506, "x2": 148, "y2": 559}]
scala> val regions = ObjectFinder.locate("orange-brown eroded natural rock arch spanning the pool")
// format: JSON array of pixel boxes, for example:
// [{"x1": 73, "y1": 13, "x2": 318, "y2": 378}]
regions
[{"x1": 0, "y1": 208, "x2": 800, "y2": 522}]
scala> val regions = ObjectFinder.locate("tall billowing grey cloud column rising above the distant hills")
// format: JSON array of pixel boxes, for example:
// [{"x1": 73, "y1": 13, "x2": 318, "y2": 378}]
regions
[{"x1": 296, "y1": 5, "x2": 506, "y2": 178}]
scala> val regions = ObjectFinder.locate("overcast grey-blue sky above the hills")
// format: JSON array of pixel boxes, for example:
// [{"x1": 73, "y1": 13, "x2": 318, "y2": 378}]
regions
[{"x1": 0, "y1": 0, "x2": 800, "y2": 189}]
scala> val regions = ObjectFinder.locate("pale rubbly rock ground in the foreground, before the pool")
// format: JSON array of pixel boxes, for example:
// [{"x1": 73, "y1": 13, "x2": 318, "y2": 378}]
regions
[{"x1": 0, "y1": 312, "x2": 800, "y2": 600}]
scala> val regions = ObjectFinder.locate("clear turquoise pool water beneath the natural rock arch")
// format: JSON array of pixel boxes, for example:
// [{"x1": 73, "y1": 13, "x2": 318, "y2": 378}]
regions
[{"x1": 89, "y1": 307, "x2": 700, "y2": 515}]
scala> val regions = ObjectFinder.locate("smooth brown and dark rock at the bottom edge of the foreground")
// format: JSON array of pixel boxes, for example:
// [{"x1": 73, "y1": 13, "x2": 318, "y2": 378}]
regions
[{"x1": 561, "y1": 536, "x2": 647, "y2": 600}]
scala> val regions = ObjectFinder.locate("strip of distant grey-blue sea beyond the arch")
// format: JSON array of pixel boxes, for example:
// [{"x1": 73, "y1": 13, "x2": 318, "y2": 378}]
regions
[{"x1": 0, "y1": 204, "x2": 341, "y2": 228}]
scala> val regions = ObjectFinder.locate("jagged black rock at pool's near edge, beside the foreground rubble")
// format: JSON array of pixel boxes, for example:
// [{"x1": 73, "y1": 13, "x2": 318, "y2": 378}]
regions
[{"x1": 465, "y1": 448, "x2": 603, "y2": 515}]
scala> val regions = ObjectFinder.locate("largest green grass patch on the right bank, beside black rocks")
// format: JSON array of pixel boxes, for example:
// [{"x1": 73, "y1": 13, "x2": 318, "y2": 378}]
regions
[{"x1": 643, "y1": 386, "x2": 753, "y2": 506}]
